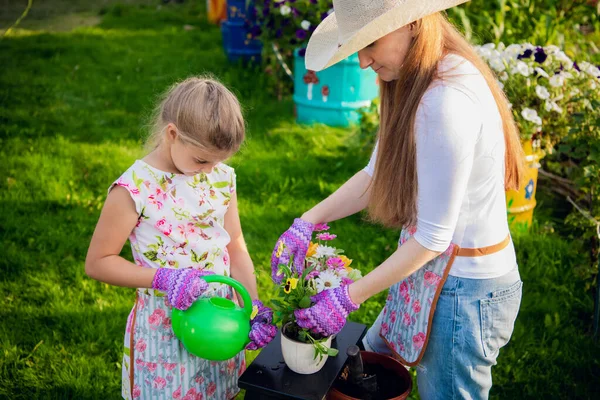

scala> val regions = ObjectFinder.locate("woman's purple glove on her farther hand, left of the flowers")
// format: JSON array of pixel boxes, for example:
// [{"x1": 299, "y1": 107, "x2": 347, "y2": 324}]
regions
[{"x1": 271, "y1": 218, "x2": 315, "y2": 284}]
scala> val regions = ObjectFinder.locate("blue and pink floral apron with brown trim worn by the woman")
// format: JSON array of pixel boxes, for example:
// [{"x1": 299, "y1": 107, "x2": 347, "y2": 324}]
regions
[{"x1": 379, "y1": 228, "x2": 511, "y2": 367}]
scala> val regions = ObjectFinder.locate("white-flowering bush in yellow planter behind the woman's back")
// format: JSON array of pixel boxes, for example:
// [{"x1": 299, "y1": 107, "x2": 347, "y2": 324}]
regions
[{"x1": 476, "y1": 43, "x2": 600, "y2": 228}]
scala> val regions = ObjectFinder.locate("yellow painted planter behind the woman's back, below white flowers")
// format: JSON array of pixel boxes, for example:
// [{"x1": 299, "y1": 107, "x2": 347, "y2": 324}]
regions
[{"x1": 506, "y1": 142, "x2": 543, "y2": 230}]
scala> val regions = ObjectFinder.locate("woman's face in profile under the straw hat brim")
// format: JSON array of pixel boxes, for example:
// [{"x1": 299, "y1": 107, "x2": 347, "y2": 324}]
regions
[{"x1": 358, "y1": 25, "x2": 414, "y2": 82}]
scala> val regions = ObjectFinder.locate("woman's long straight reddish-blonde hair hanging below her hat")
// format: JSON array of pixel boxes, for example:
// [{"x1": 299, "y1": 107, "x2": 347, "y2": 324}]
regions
[{"x1": 369, "y1": 13, "x2": 523, "y2": 228}]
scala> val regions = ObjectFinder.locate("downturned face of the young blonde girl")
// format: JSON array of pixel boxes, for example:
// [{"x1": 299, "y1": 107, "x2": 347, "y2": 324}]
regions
[{"x1": 167, "y1": 128, "x2": 231, "y2": 176}]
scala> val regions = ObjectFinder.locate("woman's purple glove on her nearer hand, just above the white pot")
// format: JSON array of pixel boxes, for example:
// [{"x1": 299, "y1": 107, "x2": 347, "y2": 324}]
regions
[{"x1": 294, "y1": 285, "x2": 359, "y2": 336}]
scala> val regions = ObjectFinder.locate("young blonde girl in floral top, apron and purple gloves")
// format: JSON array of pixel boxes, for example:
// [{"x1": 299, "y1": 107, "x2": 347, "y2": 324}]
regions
[{"x1": 85, "y1": 77, "x2": 276, "y2": 400}]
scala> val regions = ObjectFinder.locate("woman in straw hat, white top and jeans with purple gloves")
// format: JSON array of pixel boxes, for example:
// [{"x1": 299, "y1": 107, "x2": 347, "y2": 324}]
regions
[{"x1": 272, "y1": 0, "x2": 522, "y2": 399}]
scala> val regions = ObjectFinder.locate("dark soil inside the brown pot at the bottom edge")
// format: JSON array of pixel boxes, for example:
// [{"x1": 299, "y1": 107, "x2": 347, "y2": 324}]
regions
[{"x1": 334, "y1": 363, "x2": 408, "y2": 400}]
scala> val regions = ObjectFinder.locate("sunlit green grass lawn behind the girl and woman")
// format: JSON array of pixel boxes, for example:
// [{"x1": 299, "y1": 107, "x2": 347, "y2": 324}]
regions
[{"x1": 0, "y1": 0, "x2": 600, "y2": 399}]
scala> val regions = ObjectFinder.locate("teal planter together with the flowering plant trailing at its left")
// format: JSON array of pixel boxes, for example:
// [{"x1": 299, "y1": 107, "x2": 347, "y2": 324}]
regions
[{"x1": 251, "y1": 0, "x2": 379, "y2": 126}]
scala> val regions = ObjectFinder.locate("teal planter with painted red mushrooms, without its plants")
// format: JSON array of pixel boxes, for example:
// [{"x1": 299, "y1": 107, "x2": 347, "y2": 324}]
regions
[{"x1": 294, "y1": 50, "x2": 379, "y2": 126}]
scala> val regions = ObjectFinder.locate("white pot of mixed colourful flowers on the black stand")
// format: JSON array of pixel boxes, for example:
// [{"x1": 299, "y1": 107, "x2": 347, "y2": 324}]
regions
[{"x1": 271, "y1": 224, "x2": 362, "y2": 374}]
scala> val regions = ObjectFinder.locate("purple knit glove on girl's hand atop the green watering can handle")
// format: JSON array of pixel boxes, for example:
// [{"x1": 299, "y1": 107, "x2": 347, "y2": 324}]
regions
[{"x1": 152, "y1": 268, "x2": 214, "y2": 310}]
